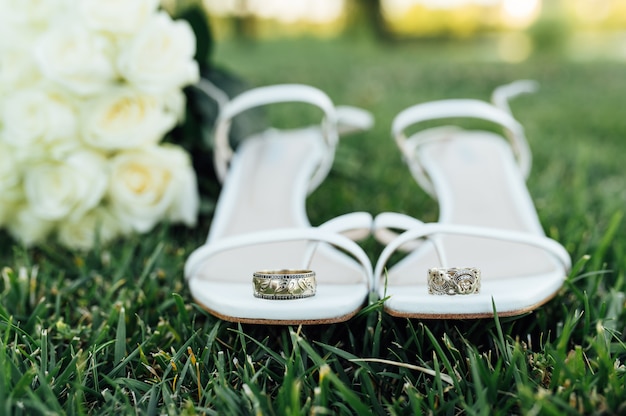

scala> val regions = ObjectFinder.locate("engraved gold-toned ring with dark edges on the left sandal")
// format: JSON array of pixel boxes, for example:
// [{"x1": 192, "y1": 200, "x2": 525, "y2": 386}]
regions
[{"x1": 252, "y1": 269, "x2": 317, "y2": 300}]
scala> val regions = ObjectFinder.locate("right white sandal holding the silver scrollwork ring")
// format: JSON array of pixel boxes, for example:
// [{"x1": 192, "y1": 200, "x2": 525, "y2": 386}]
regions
[{"x1": 374, "y1": 81, "x2": 571, "y2": 319}]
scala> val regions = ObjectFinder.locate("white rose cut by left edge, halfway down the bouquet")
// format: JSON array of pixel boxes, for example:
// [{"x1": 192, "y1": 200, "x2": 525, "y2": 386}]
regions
[{"x1": 0, "y1": 87, "x2": 77, "y2": 151}]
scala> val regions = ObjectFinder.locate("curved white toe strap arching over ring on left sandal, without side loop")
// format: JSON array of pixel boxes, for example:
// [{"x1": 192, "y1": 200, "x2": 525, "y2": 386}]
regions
[{"x1": 185, "y1": 227, "x2": 374, "y2": 289}]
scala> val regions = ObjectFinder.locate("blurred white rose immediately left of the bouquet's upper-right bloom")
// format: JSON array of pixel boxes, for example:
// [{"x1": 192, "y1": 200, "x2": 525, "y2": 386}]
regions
[{"x1": 35, "y1": 21, "x2": 116, "y2": 96}]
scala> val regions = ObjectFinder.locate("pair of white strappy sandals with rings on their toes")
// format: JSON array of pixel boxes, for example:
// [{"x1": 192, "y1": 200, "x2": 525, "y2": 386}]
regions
[{"x1": 185, "y1": 81, "x2": 571, "y2": 324}]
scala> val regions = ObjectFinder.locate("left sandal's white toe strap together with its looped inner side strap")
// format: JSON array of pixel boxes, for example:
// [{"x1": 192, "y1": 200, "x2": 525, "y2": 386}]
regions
[{"x1": 185, "y1": 212, "x2": 374, "y2": 289}]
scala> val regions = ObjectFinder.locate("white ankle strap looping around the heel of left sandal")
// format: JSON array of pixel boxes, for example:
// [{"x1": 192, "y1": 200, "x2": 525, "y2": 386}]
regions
[{"x1": 214, "y1": 84, "x2": 338, "y2": 190}]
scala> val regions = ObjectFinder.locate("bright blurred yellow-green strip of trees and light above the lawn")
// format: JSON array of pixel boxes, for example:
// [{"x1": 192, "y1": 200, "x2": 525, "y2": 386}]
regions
[{"x1": 179, "y1": 0, "x2": 626, "y2": 63}]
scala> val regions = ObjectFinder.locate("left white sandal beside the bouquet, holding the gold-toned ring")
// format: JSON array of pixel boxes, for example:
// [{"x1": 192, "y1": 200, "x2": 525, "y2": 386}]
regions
[{"x1": 185, "y1": 84, "x2": 373, "y2": 324}]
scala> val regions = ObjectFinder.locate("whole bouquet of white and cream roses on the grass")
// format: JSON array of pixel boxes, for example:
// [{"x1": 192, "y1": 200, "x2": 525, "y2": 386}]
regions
[{"x1": 0, "y1": 0, "x2": 199, "y2": 249}]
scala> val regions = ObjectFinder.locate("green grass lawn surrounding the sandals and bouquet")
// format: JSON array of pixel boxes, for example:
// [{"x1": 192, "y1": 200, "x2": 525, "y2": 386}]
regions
[{"x1": 0, "y1": 39, "x2": 626, "y2": 415}]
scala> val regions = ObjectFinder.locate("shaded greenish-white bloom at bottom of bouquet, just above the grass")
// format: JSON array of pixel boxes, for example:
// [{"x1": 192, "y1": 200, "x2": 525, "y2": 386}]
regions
[{"x1": 57, "y1": 207, "x2": 121, "y2": 250}]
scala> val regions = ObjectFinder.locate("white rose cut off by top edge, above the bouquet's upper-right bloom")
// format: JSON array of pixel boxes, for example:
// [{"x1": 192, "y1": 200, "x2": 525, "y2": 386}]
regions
[{"x1": 79, "y1": 0, "x2": 159, "y2": 34}]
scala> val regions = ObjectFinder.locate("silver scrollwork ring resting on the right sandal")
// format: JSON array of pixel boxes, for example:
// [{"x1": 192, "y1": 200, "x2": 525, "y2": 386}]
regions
[{"x1": 428, "y1": 267, "x2": 480, "y2": 295}]
